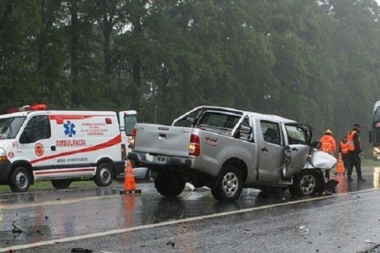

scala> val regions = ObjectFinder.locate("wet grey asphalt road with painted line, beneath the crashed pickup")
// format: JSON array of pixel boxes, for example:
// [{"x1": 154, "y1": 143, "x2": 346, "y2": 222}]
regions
[{"x1": 0, "y1": 168, "x2": 380, "y2": 252}]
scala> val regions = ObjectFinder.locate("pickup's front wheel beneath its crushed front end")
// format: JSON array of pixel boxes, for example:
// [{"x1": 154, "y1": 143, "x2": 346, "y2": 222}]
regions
[{"x1": 289, "y1": 170, "x2": 323, "y2": 196}]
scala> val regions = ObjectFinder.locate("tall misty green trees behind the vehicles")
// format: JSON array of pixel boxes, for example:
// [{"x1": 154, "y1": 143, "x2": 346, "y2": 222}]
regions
[{"x1": 0, "y1": 0, "x2": 380, "y2": 152}]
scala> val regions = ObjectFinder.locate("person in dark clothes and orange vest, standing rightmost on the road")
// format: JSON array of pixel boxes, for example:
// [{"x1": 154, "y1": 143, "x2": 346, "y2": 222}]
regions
[{"x1": 347, "y1": 124, "x2": 366, "y2": 182}]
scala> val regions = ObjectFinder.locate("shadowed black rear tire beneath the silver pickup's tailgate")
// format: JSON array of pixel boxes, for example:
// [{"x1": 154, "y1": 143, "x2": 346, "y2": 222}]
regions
[{"x1": 154, "y1": 172, "x2": 186, "y2": 198}]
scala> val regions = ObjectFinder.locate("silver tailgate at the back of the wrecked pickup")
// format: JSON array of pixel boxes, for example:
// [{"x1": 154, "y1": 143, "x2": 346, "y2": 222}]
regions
[{"x1": 133, "y1": 123, "x2": 192, "y2": 156}]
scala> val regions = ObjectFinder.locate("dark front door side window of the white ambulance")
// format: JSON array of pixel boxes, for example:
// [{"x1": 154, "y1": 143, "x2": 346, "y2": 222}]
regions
[{"x1": 20, "y1": 115, "x2": 51, "y2": 143}]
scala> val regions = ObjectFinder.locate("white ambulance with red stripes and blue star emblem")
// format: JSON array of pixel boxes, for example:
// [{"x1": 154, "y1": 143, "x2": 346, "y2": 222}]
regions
[{"x1": 0, "y1": 104, "x2": 136, "y2": 192}]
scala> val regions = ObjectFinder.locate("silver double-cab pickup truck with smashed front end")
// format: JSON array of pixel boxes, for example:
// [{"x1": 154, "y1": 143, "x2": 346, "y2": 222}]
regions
[{"x1": 128, "y1": 106, "x2": 337, "y2": 201}]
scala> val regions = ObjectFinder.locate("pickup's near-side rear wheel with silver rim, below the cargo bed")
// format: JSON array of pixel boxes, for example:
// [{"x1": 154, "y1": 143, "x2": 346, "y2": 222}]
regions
[{"x1": 211, "y1": 164, "x2": 243, "y2": 201}]
